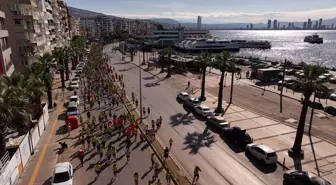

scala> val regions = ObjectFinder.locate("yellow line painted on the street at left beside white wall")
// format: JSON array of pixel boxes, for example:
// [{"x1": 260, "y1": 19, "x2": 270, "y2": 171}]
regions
[{"x1": 28, "y1": 103, "x2": 62, "y2": 185}]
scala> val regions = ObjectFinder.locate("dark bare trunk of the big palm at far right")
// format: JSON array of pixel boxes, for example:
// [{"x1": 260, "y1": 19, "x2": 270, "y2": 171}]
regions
[{"x1": 290, "y1": 98, "x2": 310, "y2": 157}]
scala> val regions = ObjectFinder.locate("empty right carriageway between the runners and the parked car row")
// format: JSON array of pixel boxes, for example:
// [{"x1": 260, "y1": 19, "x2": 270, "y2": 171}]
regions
[{"x1": 107, "y1": 44, "x2": 283, "y2": 185}]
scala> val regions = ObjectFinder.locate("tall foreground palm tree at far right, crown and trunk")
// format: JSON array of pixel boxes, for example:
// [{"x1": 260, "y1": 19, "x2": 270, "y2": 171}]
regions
[{"x1": 288, "y1": 65, "x2": 325, "y2": 157}]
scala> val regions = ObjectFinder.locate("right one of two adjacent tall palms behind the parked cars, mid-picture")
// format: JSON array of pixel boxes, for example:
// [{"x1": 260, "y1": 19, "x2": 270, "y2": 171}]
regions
[{"x1": 213, "y1": 51, "x2": 233, "y2": 112}]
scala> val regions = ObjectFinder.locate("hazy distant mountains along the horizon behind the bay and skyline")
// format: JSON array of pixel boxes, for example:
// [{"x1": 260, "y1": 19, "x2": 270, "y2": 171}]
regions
[{"x1": 68, "y1": 6, "x2": 336, "y2": 30}]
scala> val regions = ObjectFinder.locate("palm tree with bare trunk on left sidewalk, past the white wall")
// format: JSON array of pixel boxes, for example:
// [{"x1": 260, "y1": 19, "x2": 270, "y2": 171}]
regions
[{"x1": 30, "y1": 53, "x2": 56, "y2": 108}]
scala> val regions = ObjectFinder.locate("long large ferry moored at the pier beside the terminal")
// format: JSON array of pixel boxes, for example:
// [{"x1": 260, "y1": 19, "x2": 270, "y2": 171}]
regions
[{"x1": 174, "y1": 39, "x2": 239, "y2": 52}]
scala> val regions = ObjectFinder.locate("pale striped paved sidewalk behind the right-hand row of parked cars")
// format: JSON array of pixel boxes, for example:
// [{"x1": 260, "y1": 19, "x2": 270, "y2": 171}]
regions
[{"x1": 124, "y1": 51, "x2": 336, "y2": 184}]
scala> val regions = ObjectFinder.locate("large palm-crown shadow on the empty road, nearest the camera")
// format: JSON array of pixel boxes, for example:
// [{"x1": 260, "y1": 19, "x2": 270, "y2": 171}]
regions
[{"x1": 183, "y1": 128, "x2": 216, "y2": 154}]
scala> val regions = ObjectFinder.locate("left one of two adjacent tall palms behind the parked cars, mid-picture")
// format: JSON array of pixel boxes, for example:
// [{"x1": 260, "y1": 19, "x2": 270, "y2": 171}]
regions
[{"x1": 197, "y1": 52, "x2": 212, "y2": 101}]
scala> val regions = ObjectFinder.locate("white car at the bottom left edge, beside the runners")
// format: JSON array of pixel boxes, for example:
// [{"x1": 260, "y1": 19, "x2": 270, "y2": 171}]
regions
[{"x1": 51, "y1": 162, "x2": 73, "y2": 185}]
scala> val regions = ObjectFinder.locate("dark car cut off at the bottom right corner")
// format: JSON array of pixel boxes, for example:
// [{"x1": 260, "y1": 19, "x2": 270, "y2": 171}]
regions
[{"x1": 283, "y1": 170, "x2": 331, "y2": 185}]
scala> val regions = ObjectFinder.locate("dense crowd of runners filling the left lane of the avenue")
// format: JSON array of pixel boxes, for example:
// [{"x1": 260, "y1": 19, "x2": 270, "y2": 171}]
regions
[{"x1": 68, "y1": 45, "x2": 200, "y2": 185}]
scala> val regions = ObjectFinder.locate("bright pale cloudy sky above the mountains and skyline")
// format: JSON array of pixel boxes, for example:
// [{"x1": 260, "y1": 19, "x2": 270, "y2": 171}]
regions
[{"x1": 65, "y1": 0, "x2": 336, "y2": 23}]
